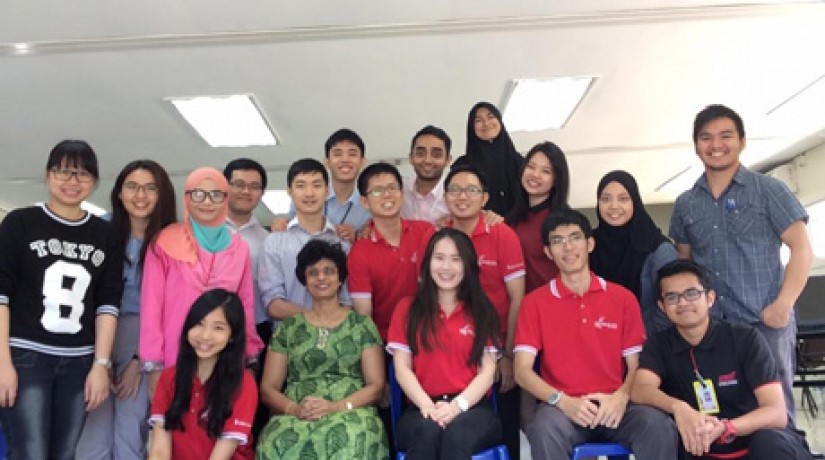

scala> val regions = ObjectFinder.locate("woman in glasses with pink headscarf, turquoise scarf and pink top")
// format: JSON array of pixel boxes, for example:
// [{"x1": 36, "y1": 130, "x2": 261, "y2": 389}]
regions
[{"x1": 140, "y1": 168, "x2": 263, "y2": 394}]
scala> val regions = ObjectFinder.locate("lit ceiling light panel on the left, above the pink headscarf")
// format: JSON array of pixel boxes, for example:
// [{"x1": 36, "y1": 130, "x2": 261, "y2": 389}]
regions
[{"x1": 167, "y1": 94, "x2": 278, "y2": 147}]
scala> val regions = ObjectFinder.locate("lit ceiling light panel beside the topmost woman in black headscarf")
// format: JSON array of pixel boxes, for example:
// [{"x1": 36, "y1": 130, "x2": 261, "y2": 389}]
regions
[{"x1": 504, "y1": 77, "x2": 595, "y2": 131}]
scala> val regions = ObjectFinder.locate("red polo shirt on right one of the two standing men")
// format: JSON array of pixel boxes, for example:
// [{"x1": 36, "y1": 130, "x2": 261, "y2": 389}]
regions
[{"x1": 449, "y1": 214, "x2": 524, "y2": 337}]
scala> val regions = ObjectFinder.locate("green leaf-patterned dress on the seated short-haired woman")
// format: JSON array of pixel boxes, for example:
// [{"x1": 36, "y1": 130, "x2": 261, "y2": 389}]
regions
[{"x1": 256, "y1": 312, "x2": 389, "y2": 460}]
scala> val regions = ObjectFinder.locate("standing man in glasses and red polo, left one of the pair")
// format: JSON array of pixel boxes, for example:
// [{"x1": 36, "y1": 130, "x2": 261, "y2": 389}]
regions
[{"x1": 347, "y1": 162, "x2": 435, "y2": 341}]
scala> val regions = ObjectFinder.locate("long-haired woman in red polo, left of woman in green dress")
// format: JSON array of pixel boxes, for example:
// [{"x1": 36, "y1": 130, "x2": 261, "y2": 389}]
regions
[{"x1": 149, "y1": 288, "x2": 258, "y2": 460}]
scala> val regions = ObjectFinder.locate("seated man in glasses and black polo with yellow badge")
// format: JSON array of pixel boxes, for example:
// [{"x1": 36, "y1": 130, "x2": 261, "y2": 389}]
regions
[{"x1": 632, "y1": 259, "x2": 812, "y2": 460}]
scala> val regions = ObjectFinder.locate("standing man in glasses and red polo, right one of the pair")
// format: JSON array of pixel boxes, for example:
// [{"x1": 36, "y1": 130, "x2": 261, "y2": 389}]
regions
[{"x1": 444, "y1": 165, "x2": 525, "y2": 458}]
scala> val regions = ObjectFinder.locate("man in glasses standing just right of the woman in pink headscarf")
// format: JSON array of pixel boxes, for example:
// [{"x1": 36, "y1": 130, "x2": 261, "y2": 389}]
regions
[{"x1": 223, "y1": 158, "x2": 272, "y2": 438}]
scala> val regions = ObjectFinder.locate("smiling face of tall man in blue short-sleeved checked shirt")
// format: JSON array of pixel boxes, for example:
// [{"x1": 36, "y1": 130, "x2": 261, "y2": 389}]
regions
[{"x1": 694, "y1": 117, "x2": 745, "y2": 171}]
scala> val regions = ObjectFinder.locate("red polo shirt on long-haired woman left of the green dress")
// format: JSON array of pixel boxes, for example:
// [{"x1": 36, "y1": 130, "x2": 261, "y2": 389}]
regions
[{"x1": 149, "y1": 367, "x2": 258, "y2": 460}]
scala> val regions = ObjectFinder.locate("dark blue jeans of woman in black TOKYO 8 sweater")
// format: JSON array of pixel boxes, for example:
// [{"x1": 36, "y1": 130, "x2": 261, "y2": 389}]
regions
[{"x1": 0, "y1": 347, "x2": 94, "y2": 460}]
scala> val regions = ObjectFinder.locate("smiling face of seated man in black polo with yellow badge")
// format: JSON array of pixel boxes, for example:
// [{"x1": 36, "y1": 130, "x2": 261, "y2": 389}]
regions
[{"x1": 658, "y1": 272, "x2": 716, "y2": 329}]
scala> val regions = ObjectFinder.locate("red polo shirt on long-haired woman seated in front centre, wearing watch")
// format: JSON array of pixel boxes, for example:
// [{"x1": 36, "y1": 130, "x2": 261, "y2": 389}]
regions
[{"x1": 387, "y1": 297, "x2": 497, "y2": 397}]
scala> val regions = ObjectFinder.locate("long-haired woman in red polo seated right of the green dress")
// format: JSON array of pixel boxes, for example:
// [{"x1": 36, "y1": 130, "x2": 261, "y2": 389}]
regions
[{"x1": 387, "y1": 228, "x2": 501, "y2": 460}]
